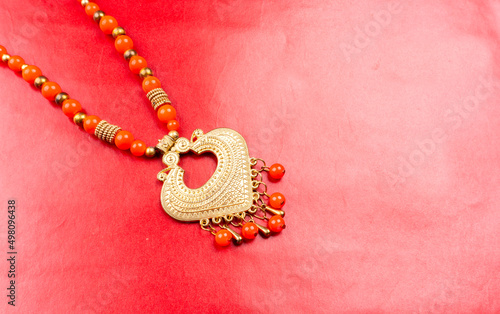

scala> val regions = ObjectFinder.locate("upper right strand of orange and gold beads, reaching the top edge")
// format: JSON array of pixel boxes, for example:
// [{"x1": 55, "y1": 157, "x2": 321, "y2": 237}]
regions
[{"x1": 79, "y1": 0, "x2": 180, "y2": 131}]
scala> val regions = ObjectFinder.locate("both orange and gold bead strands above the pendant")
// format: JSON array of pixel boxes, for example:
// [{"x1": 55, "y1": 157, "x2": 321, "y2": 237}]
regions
[{"x1": 0, "y1": 0, "x2": 179, "y2": 157}]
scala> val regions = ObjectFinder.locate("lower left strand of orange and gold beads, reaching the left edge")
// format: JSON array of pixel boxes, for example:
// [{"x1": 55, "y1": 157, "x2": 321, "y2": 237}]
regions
[{"x1": 0, "y1": 46, "x2": 156, "y2": 157}]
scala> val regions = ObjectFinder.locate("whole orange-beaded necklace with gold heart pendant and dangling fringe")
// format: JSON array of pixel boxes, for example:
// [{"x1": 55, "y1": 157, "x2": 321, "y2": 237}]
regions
[{"x1": 0, "y1": 0, "x2": 285, "y2": 246}]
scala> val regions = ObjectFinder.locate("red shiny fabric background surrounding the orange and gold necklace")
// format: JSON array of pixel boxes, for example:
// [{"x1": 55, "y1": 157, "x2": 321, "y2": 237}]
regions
[{"x1": 0, "y1": 0, "x2": 500, "y2": 313}]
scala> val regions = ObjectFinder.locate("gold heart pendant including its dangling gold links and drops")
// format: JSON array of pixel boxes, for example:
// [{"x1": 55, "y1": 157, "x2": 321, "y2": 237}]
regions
[{"x1": 156, "y1": 128, "x2": 284, "y2": 244}]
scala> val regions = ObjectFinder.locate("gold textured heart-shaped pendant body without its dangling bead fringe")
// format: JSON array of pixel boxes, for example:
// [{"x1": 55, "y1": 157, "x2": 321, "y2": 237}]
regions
[{"x1": 158, "y1": 128, "x2": 253, "y2": 221}]
